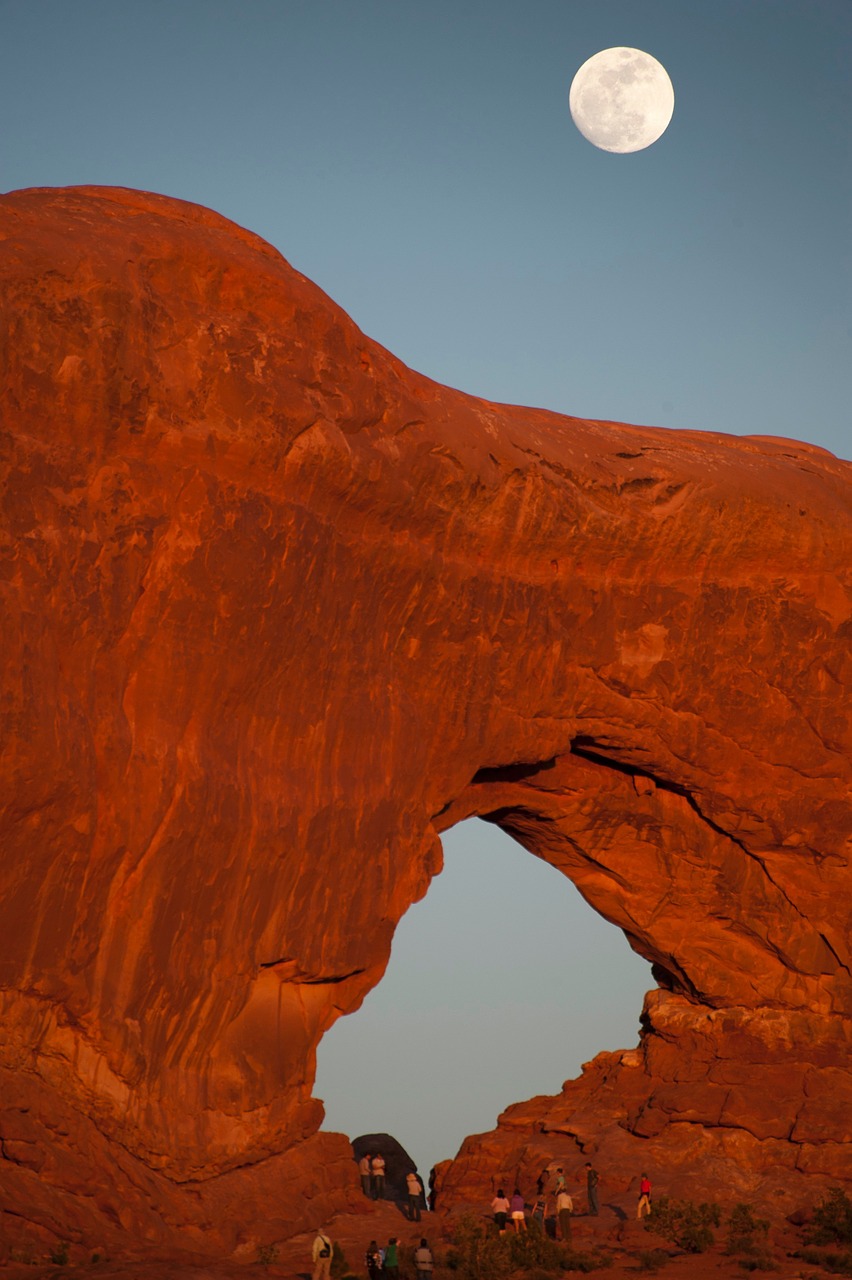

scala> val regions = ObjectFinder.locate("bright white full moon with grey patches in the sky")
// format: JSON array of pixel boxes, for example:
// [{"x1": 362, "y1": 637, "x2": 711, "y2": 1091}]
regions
[{"x1": 568, "y1": 47, "x2": 674, "y2": 154}]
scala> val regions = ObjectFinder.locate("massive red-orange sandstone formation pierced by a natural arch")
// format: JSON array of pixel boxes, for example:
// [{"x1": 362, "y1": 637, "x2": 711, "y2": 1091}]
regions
[{"x1": 0, "y1": 188, "x2": 852, "y2": 1254}]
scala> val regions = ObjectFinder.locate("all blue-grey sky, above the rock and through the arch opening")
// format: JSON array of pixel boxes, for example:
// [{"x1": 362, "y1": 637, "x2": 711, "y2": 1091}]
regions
[{"x1": 0, "y1": 0, "x2": 852, "y2": 1170}]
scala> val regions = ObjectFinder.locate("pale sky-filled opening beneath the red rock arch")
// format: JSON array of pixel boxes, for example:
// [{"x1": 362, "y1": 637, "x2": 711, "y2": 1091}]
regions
[{"x1": 313, "y1": 819, "x2": 652, "y2": 1175}]
